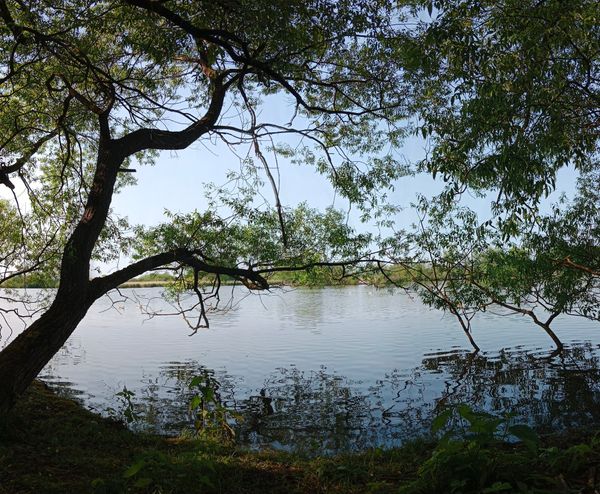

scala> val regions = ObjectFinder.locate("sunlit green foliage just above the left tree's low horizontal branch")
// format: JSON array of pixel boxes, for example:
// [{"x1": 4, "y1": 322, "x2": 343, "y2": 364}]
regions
[{"x1": 135, "y1": 203, "x2": 370, "y2": 276}]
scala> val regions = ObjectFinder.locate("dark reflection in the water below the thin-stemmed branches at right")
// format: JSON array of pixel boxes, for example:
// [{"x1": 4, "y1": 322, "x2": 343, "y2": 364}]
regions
[{"x1": 423, "y1": 342, "x2": 600, "y2": 430}]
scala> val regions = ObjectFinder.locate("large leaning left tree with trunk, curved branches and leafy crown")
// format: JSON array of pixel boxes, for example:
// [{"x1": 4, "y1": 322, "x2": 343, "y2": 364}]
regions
[{"x1": 0, "y1": 0, "x2": 406, "y2": 412}]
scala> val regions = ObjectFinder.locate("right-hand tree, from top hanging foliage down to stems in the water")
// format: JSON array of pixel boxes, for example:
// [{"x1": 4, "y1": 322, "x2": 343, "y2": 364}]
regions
[{"x1": 386, "y1": 0, "x2": 600, "y2": 350}]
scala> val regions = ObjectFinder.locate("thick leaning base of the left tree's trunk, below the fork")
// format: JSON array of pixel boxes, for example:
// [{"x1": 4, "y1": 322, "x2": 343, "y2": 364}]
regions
[{"x1": 0, "y1": 297, "x2": 91, "y2": 416}]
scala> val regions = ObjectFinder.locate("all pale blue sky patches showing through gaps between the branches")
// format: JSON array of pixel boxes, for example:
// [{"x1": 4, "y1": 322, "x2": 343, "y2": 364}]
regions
[{"x1": 103, "y1": 86, "x2": 577, "y2": 235}]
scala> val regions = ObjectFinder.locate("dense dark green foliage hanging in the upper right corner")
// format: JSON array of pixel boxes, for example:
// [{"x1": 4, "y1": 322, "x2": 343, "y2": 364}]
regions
[{"x1": 406, "y1": 0, "x2": 600, "y2": 227}]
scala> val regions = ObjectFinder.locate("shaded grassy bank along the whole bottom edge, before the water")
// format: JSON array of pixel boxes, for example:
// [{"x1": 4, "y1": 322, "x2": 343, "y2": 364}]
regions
[{"x1": 0, "y1": 383, "x2": 600, "y2": 494}]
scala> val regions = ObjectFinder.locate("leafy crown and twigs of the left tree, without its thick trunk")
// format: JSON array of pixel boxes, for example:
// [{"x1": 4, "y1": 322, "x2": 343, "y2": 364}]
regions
[{"x1": 0, "y1": 0, "x2": 406, "y2": 302}]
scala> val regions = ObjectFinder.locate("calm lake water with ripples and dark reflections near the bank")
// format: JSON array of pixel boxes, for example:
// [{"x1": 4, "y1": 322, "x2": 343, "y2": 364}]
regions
[{"x1": 1, "y1": 286, "x2": 600, "y2": 452}]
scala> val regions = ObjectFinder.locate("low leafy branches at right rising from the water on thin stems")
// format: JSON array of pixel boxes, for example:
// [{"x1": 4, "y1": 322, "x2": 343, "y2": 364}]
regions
[{"x1": 390, "y1": 167, "x2": 600, "y2": 348}]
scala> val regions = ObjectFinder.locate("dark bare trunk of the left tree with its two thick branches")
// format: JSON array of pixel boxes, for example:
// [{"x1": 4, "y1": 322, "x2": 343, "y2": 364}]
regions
[{"x1": 0, "y1": 68, "x2": 237, "y2": 412}]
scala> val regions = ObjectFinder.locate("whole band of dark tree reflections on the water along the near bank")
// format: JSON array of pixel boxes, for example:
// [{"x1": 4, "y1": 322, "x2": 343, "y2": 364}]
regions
[{"x1": 47, "y1": 342, "x2": 600, "y2": 454}]
